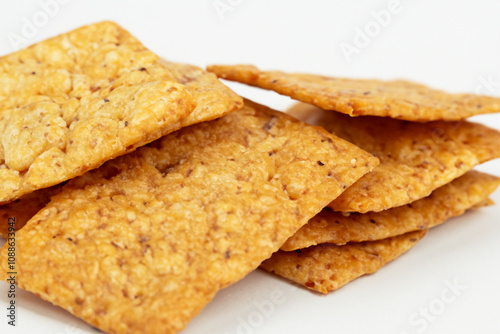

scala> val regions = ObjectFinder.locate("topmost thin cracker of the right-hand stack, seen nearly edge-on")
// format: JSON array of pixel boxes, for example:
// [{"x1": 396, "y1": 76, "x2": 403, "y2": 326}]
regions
[{"x1": 207, "y1": 65, "x2": 500, "y2": 122}]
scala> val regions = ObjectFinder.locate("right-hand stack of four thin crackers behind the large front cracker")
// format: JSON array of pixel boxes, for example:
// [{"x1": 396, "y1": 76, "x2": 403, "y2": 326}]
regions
[{"x1": 208, "y1": 65, "x2": 500, "y2": 293}]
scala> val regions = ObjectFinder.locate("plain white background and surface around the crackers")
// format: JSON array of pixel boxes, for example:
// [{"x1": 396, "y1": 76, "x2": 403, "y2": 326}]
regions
[{"x1": 0, "y1": 0, "x2": 500, "y2": 334}]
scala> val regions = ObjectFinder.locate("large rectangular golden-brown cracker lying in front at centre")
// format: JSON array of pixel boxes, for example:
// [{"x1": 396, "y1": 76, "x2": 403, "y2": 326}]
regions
[{"x1": 0, "y1": 102, "x2": 378, "y2": 333}]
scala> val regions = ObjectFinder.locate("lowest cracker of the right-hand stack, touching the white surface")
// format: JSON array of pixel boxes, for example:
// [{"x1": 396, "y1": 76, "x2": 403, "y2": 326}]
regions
[{"x1": 261, "y1": 230, "x2": 427, "y2": 293}]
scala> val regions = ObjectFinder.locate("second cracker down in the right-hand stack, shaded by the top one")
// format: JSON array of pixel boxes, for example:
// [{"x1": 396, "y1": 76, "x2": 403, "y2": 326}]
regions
[{"x1": 288, "y1": 104, "x2": 500, "y2": 213}]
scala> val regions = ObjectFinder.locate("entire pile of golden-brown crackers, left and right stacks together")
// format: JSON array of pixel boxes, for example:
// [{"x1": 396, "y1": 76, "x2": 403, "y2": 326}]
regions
[{"x1": 0, "y1": 22, "x2": 500, "y2": 333}]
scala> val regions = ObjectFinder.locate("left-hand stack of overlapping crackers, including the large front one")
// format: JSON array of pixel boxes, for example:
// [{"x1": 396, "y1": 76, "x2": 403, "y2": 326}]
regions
[{"x1": 0, "y1": 22, "x2": 379, "y2": 333}]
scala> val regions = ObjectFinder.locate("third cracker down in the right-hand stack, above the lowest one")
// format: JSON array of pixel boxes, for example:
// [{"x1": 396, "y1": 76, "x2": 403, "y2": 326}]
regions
[{"x1": 281, "y1": 171, "x2": 500, "y2": 251}]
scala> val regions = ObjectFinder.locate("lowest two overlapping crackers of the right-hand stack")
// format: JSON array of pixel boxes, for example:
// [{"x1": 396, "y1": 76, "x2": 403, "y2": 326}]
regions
[{"x1": 261, "y1": 171, "x2": 500, "y2": 293}]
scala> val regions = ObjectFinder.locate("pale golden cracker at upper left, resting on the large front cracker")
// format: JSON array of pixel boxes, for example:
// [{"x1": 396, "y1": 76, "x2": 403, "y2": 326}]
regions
[{"x1": 0, "y1": 22, "x2": 242, "y2": 203}]
